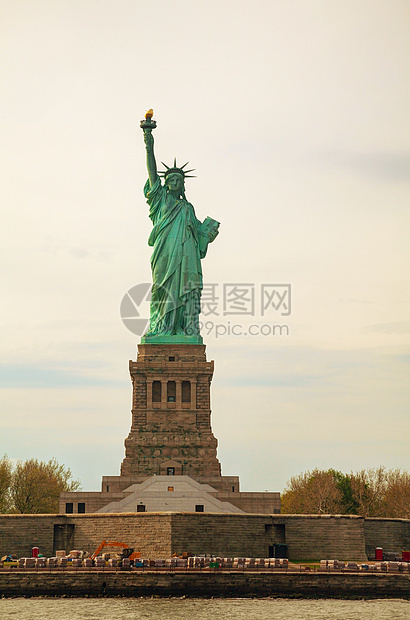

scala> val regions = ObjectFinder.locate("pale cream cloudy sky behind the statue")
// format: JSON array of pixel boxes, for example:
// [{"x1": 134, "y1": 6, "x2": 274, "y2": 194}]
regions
[{"x1": 0, "y1": 0, "x2": 410, "y2": 491}]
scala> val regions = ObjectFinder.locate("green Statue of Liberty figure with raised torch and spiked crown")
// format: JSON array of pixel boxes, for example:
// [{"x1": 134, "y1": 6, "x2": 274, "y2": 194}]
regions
[{"x1": 141, "y1": 110, "x2": 219, "y2": 344}]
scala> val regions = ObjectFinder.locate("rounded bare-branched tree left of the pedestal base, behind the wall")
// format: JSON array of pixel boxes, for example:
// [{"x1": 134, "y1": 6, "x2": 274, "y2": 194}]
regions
[{"x1": 10, "y1": 459, "x2": 80, "y2": 514}]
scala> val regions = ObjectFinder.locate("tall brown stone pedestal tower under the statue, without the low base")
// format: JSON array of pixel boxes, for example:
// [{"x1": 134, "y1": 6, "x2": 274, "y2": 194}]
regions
[{"x1": 121, "y1": 344, "x2": 221, "y2": 478}]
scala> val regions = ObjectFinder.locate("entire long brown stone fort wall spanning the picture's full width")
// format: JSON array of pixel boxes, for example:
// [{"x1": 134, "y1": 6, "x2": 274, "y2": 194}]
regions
[{"x1": 0, "y1": 512, "x2": 410, "y2": 561}]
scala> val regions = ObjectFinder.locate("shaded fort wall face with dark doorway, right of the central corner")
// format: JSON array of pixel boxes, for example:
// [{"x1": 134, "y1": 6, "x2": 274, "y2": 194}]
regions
[{"x1": 172, "y1": 513, "x2": 367, "y2": 561}]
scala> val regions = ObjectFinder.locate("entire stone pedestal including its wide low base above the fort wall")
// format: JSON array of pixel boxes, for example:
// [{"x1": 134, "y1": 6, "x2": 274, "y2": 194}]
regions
[{"x1": 60, "y1": 342, "x2": 280, "y2": 512}]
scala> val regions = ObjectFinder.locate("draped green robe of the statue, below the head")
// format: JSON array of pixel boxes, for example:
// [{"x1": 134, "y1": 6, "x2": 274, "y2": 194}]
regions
[{"x1": 144, "y1": 178, "x2": 206, "y2": 336}]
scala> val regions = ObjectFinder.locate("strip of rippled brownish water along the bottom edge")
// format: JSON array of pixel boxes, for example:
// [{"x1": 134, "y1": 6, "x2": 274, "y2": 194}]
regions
[{"x1": 0, "y1": 598, "x2": 410, "y2": 620}]
